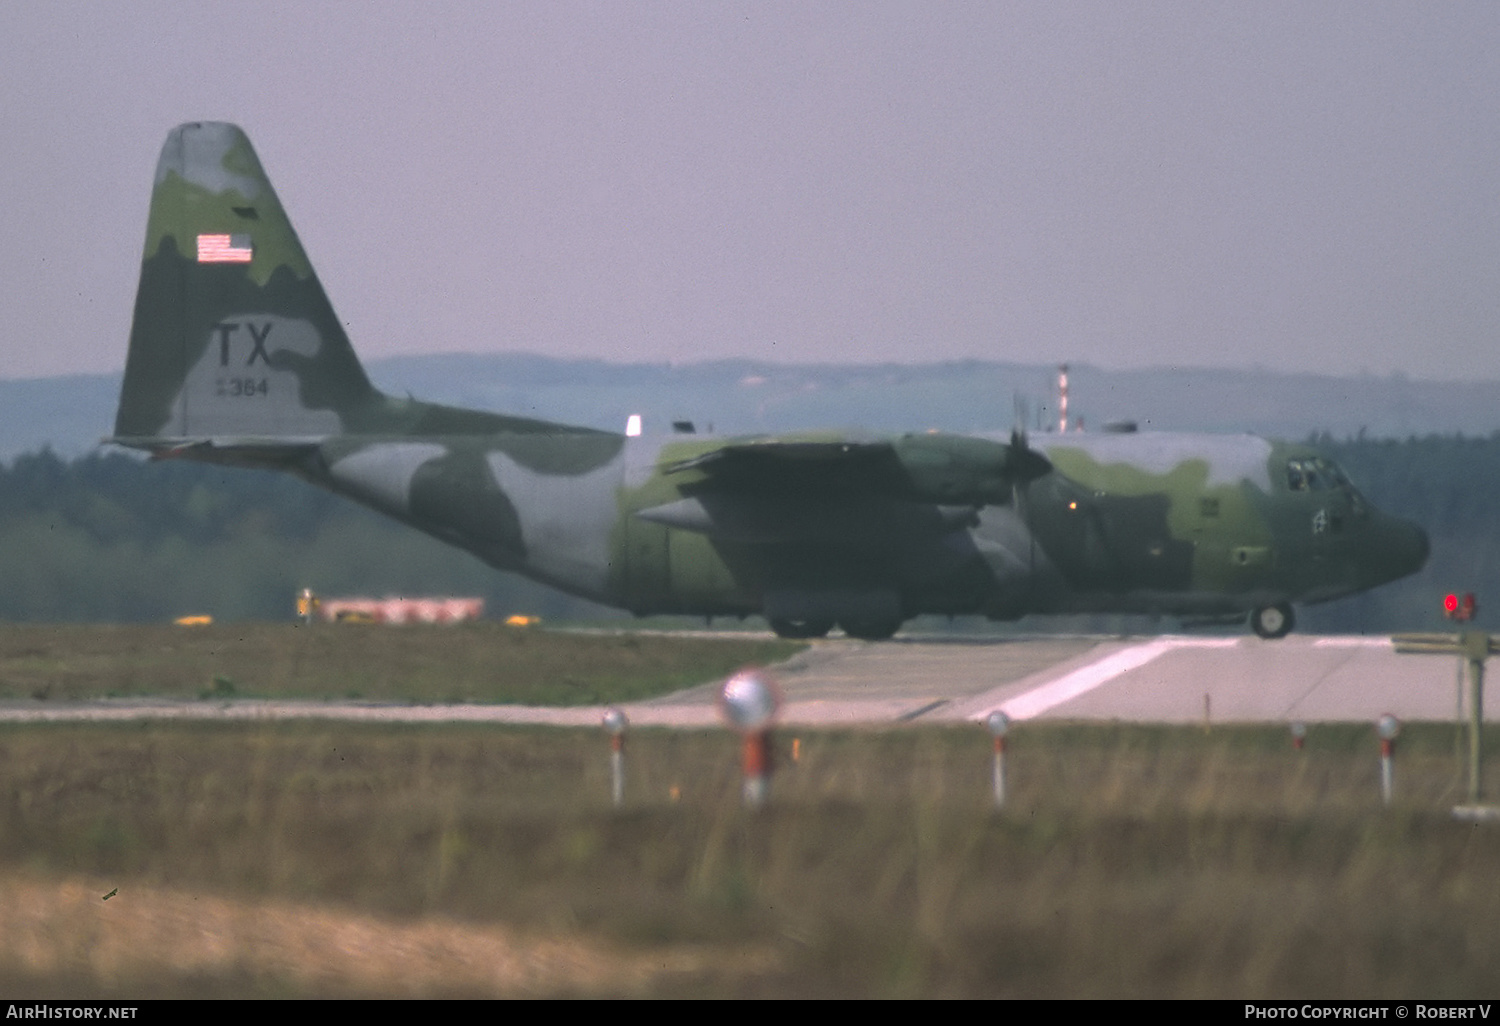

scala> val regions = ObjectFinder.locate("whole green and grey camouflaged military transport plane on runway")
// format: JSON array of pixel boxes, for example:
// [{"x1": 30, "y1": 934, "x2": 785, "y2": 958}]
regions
[{"x1": 110, "y1": 123, "x2": 1428, "y2": 639}]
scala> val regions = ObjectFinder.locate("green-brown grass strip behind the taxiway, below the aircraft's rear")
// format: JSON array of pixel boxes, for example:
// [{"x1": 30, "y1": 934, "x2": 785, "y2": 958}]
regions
[{"x1": 0, "y1": 623, "x2": 803, "y2": 705}]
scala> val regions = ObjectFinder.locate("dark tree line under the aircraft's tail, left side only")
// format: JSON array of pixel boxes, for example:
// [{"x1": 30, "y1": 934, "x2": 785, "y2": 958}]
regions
[{"x1": 0, "y1": 450, "x2": 599, "y2": 623}]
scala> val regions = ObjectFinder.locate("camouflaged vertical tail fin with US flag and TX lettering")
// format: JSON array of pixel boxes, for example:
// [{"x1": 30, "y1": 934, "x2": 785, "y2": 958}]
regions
[{"x1": 114, "y1": 122, "x2": 384, "y2": 449}]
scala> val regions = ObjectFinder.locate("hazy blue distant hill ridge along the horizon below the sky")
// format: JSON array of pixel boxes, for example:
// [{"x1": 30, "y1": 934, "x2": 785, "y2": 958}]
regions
[{"x1": 0, "y1": 353, "x2": 1500, "y2": 459}]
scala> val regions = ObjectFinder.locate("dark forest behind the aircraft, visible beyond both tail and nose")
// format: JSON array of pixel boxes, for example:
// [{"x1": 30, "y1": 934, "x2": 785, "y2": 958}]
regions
[{"x1": 0, "y1": 434, "x2": 1500, "y2": 633}]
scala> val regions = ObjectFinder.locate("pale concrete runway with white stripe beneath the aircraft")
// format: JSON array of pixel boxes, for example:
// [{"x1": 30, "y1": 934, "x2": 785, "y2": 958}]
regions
[{"x1": 0, "y1": 636, "x2": 1476, "y2": 728}]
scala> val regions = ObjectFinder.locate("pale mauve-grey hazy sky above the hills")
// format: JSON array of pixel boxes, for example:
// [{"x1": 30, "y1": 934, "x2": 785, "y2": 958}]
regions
[{"x1": 0, "y1": 0, "x2": 1500, "y2": 380}]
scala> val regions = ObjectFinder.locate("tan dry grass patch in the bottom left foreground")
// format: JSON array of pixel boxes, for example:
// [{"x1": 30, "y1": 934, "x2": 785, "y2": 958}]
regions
[{"x1": 0, "y1": 875, "x2": 776, "y2": 998}]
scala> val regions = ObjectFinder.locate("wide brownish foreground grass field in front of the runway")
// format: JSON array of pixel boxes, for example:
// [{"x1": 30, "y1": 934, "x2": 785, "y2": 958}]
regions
[{"x1": 0, "y1": 723, "x2": 1500, "y2": 999}]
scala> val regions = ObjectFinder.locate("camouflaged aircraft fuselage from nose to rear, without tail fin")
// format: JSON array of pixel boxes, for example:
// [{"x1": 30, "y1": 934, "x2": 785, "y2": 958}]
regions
[{"x1": 303, "y1": 429, "x2": 1427, "y2": 635}]
